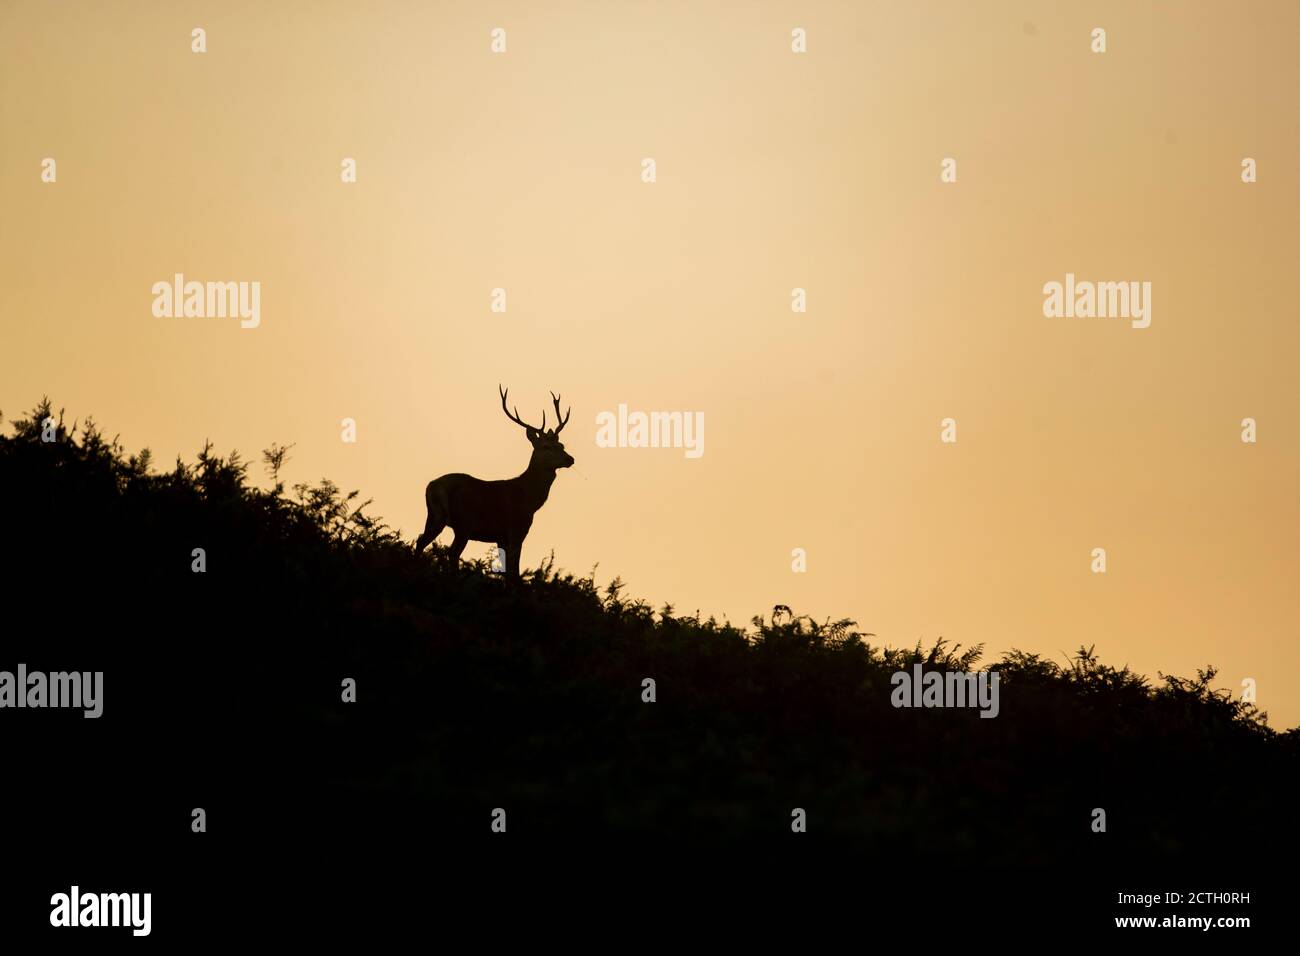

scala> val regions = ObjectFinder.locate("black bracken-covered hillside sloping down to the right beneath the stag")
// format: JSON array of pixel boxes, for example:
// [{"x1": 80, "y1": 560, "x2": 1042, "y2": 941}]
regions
[{"x1": 0, "y1": 398, "x2": 1300, "y2": 940}]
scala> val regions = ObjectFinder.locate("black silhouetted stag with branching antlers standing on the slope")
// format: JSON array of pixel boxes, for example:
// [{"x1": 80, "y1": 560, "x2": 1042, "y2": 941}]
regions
[{"x1": 415, "y1": 385, "x2": 573, "y2": 578}]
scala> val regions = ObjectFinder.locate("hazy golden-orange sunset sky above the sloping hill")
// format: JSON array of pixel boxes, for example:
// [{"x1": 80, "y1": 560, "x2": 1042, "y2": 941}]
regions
[{"x1": 0, "y1": 0, "x2": 1300, "y2": 727}]
